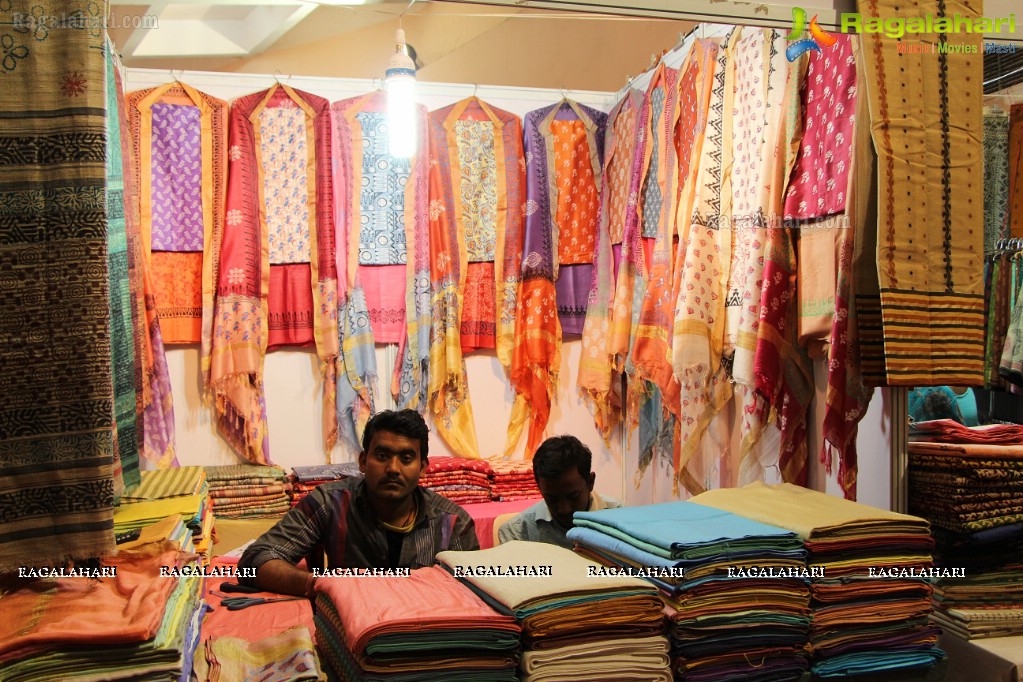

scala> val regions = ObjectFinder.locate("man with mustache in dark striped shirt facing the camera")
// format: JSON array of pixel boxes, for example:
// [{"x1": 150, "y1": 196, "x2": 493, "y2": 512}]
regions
[{"x1": 238, "y1": 410, "x2": 480, "y2": 597}]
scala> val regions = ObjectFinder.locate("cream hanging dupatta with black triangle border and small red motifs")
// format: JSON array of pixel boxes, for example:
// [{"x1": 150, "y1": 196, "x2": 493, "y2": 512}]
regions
[{"x1": 671, "y1": 40, "x2": 731, "y2": 492}]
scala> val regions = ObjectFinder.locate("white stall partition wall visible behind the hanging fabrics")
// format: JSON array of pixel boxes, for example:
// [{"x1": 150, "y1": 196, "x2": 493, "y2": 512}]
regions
[{"x1": 125, "y1": 69, "x2": 890, "y2": 507}]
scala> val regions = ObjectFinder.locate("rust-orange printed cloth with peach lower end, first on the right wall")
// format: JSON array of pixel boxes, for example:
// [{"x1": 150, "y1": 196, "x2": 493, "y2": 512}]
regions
[{"x1": 576, "y1": 90, "x2": 643, "y2": 444}]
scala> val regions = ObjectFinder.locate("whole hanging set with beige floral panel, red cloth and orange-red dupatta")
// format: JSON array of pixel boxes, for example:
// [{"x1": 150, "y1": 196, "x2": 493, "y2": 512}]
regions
[{"x1": 429, "y1": 97, "x2": 525, "y2": 458}]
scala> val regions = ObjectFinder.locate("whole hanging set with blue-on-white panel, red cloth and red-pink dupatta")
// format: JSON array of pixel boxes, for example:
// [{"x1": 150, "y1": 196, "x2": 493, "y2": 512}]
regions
[{"x1": 211, "y1": 84, "x2": 338, "y2": 464}]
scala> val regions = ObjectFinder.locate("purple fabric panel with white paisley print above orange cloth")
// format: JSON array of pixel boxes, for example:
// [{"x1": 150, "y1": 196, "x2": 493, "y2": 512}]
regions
[{"x1": 151, "y1": 103, "x2": 203, "y2": 252}]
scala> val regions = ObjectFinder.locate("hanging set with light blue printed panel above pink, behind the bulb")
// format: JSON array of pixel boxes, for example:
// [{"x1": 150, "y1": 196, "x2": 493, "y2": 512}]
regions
[{"x1": 331, "y1": 91, "x2": 431, "y2": 452}]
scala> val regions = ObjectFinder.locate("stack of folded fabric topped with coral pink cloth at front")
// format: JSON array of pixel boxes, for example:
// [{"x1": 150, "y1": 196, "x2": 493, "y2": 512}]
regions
[{"x1": 315, "y1": 566, "x2": 520, "y2": 682}]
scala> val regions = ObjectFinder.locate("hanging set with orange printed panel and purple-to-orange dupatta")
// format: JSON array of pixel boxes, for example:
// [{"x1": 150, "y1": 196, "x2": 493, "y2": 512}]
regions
[{"x1": 504, "y1": 99, "x2": 607, "y2": 457}]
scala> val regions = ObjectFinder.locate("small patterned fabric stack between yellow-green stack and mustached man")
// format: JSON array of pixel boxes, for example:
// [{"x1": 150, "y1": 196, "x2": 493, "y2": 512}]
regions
[{"x1": 206, "y1": 464, "x2": 292, "y2": 518}]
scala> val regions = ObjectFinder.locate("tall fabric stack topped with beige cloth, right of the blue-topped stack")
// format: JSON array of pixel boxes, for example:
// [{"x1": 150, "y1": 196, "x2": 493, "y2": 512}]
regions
[{"x1": 691, "y1": 483, "x2": 944, "y2": 679}]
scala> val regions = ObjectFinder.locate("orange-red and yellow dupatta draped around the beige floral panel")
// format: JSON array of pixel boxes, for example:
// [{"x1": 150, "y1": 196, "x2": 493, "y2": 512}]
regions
[{"x1": 429, "y1": 97, "x2": 525, "y2": 459}]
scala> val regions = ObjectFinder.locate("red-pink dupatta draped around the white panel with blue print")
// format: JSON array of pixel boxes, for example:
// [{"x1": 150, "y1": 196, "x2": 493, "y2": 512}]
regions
[{"x1": 211, "y1": 84, "x2": 339, "y2": 464}]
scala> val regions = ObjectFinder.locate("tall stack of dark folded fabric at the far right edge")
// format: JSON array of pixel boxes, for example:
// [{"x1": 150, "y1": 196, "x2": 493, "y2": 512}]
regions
[{"x1": 908, "y1": 437, "x2": 1023, "y2": 639}]
